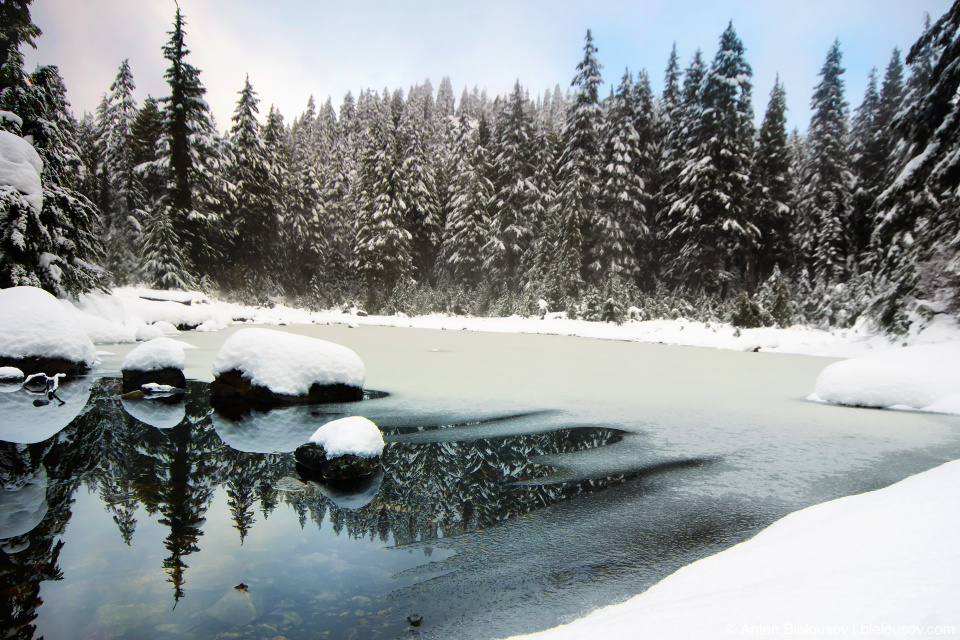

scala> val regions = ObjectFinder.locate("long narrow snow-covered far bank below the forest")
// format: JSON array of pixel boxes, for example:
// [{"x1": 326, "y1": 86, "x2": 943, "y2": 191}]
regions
[{"x1": 73, "y1": 288, "x2": 960, "y2": 358}]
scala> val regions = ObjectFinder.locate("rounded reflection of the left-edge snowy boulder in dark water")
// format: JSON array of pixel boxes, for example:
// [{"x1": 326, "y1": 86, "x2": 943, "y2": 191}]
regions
[{"x1": 0, "y1": 378, "x2": 92, "y2": 444}]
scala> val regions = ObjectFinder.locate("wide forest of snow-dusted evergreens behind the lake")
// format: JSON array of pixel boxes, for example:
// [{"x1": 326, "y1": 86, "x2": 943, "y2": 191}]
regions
[{"x1": 3, "y1": 3, "x2": 960, "y2": 331}]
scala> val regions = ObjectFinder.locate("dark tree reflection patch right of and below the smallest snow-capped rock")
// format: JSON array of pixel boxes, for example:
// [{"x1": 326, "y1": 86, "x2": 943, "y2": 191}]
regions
[{"x1": 286, "y1": 428, "x2": 622, "y2": 545}]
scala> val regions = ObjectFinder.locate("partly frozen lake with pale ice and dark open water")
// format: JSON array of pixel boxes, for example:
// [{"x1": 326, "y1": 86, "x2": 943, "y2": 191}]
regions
[{"x1": 0, "y1": 325, "x2": 960, "y2": 638}]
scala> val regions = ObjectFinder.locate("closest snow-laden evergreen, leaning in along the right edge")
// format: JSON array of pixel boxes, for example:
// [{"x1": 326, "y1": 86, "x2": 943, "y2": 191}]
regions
[{"x1": 874, "y1": 2, "x2": 960, "y2": 329}]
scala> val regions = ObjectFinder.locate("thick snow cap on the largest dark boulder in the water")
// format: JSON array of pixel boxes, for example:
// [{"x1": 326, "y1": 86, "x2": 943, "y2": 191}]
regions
[{"x1": 213, "y1": 329, "x2": 366, "y2": 396}]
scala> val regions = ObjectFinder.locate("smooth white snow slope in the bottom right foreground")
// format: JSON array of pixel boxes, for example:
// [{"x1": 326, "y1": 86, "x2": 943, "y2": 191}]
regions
[{"x1": 512, "y1": 461, "x2": 960, "y2": 640}]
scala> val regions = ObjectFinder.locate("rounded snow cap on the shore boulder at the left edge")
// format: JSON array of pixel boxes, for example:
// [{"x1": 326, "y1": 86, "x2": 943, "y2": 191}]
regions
[{"x1": 0, "y1": 287, "x2": 97, "y2": 366}]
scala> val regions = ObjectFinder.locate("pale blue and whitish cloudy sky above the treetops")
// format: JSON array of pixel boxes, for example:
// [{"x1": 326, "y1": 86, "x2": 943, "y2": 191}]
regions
[{"x1": 20, "y1": 0, "x2": 951, "y2": 130}]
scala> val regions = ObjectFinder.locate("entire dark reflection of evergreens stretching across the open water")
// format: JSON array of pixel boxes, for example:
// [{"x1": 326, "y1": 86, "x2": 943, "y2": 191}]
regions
[{"x1": 0, "y1": 379, "x2": 619, "y2": 638}]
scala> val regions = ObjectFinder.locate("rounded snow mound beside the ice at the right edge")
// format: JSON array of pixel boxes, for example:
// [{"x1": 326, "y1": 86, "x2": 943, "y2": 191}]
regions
[{"x1": 810, "y1": 342, "x2": 960, "y2": 414}]
